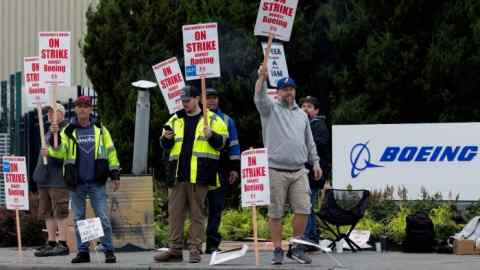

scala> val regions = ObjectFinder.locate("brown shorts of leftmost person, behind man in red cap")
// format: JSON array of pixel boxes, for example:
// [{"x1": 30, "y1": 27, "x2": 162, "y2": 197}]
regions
[{"x1": 38, "y1": 188, "x2": 69, "y2": 219}]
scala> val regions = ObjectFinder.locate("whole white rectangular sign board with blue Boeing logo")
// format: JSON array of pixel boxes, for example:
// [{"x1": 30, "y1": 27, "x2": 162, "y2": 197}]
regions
[{"x1": 332, "y1": 122, "x2": 480, "y2": 200}]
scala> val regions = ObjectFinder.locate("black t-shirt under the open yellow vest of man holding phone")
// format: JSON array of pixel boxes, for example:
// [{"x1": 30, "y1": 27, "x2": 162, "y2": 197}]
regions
[{"x1": 178, "y1": 113, "x2": 202, "y2": 182}]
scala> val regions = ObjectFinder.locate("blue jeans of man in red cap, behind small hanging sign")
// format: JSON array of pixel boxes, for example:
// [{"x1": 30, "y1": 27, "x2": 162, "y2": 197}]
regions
[{"x1": 70, "y1": 183, "x2": 113, "y2": 252}]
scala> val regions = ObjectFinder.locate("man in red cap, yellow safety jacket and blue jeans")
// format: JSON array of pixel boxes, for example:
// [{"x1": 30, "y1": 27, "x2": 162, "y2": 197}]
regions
[{"x1": 48, "y1": 96, "x2": 120, "y2": 263}]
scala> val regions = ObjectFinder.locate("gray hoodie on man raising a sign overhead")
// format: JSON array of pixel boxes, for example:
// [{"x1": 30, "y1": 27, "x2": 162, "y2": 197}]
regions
[{"x1": 254, "y1": 84, "x2": 320, "y2": 170}]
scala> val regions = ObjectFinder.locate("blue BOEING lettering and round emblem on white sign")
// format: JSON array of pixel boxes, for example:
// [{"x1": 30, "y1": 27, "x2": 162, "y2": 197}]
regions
[{"x1": 350, "y1": 141, "x2": 478, "y2": 178}]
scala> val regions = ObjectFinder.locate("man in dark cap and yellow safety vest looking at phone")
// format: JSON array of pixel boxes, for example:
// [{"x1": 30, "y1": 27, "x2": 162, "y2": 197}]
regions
[{"x1": 154, "y1": 86, "x2": 228, "y2": 263}]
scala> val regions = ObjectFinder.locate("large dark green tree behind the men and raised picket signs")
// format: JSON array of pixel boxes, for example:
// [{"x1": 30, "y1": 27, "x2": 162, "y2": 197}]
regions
[{"x1": 82, "y1": 0, "x2": 332, "y2": 171}]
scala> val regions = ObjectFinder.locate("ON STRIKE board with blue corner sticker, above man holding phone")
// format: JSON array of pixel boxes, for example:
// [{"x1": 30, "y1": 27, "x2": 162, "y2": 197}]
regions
[{"x1": 183, "y1": 23, "x2": 220, "y2": 81}]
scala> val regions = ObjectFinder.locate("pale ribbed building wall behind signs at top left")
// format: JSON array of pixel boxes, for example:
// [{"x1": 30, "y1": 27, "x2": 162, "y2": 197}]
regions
[{"x1": 0, "y1": 0, "x2": 98, "y2": 86}]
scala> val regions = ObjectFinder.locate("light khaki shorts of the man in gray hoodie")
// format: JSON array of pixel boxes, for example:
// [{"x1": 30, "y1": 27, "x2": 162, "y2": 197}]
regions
[{"x1": 268, "y1": 168, "x2": 312, "y2": 218}]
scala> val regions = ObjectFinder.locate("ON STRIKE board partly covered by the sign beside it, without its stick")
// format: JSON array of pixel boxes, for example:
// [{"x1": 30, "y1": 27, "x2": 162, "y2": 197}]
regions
[{"x1": 23, "y1": 56, "x2": 48, "y2": 107}]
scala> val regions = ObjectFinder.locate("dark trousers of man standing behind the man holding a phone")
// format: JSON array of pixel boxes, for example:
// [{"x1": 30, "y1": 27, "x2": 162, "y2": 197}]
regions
[{"x1": 206, "y1": 184, "x2": 227, "y2": 249}]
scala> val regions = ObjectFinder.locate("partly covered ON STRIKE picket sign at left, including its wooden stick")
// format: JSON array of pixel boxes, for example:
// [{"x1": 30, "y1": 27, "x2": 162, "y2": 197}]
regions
[{"x1": 23, "y1": 56, "x2": 49, "y2": 165}]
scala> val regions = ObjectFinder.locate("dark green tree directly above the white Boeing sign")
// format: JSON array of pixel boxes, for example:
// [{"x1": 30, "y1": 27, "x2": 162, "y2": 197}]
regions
[{"x1": 320, "y1": 0, "x2": 480, "y2": 123}]
